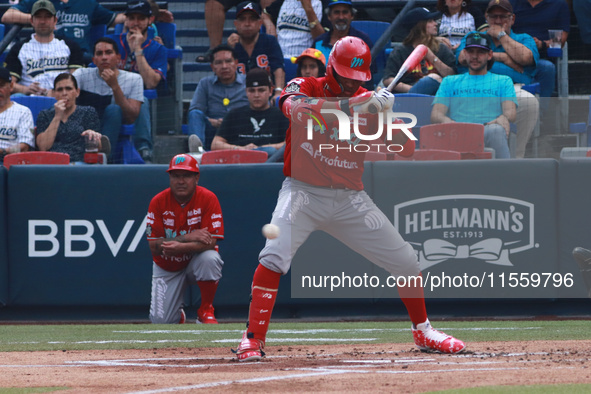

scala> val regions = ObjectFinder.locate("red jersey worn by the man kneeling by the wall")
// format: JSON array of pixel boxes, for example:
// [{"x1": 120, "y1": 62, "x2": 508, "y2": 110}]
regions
[{"x1": 146, "y1": 186, "x2": 224, "y2": 271}]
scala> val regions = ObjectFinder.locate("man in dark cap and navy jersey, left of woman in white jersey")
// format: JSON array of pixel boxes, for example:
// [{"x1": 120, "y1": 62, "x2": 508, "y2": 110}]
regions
[{"x1": 228, "y1": 1, "x2": 285, "y2": 98}]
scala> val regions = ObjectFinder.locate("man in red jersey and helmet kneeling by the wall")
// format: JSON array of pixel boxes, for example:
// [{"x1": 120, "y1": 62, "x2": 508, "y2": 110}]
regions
[{"x1": 146, "y1": 154, "x2": 224, "y2": 324}]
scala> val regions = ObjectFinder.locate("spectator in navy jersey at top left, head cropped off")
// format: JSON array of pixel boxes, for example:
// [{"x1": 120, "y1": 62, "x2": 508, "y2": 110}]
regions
[{"x1": 2, "y1": 0, "x2": 125, "y2": 64}]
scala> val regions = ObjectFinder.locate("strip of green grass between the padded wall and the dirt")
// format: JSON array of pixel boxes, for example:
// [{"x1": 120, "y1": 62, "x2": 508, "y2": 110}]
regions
[{"x1": 0, "y1": 320, "x2": 591, "y2": 352}]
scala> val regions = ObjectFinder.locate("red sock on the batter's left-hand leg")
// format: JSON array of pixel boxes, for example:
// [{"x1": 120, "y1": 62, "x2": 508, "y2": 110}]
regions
[{"x1": 247, "y1": 264, "x2": 281, "y2": 343}]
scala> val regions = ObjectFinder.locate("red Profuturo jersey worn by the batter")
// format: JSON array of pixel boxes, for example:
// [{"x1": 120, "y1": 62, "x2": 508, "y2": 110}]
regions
[{"x1": 281, "y1": 77, "x2": 377, "y2": 190}]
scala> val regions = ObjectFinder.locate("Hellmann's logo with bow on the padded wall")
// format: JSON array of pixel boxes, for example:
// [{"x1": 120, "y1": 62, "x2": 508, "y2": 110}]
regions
[{"x1": 394, "y1": 194, "x2": 539, "y2": 269}]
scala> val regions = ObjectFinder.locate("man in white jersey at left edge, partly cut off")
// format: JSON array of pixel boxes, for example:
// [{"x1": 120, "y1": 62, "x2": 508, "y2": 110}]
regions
[{"x1": 0, "y1": 67, "x2": 35, "y2": 162}]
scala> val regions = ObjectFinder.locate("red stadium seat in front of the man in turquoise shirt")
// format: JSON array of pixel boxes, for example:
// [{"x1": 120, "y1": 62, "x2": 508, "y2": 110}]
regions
[{"x1": 420, "y1": 123, "x2": 492, "y2": 159}]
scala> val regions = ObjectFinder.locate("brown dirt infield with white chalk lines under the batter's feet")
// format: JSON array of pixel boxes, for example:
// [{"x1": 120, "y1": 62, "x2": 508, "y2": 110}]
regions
[{"x1": 0, "y1": 341, "x2": 591, "y2": 393}]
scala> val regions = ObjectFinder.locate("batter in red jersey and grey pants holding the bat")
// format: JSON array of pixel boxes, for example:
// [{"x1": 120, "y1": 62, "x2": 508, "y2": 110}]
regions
[{"x1": 236, "y1": 37, "x2": 466, "y2": 361}]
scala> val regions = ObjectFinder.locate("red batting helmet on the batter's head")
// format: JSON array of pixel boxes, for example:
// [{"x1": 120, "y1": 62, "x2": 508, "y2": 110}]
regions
[{"x1": 326, "y1": 36, "x2": 371, "y2": 94}]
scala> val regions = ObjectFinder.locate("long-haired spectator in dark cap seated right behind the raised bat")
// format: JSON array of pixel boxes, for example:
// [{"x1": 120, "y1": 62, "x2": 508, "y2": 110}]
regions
[{"x1": 383, "y1": 8, "x2": 456, "y2": 96}]
